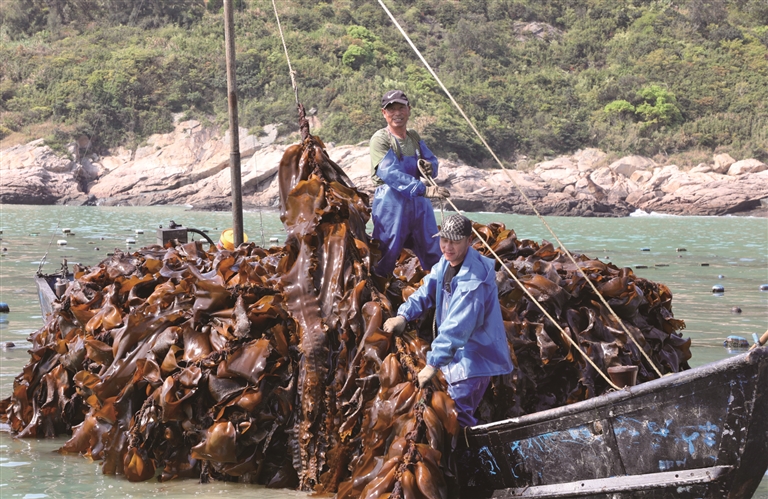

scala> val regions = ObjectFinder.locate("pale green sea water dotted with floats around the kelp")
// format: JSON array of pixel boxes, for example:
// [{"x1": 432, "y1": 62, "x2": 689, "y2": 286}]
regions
[{"x1": 0, "y1": 205, "x2": 768, "y2": 499}]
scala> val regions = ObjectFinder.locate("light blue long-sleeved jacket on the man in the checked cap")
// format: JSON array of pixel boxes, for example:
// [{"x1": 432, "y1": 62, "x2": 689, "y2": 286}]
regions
[{"x1": 397, "y1": 247, "x2": 513, "y2": 383}]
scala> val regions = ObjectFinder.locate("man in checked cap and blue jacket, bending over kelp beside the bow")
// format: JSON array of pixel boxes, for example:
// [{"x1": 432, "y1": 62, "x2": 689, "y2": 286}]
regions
[{"x1": 382, "y1": 214, "x2": 513, "y2": 426}]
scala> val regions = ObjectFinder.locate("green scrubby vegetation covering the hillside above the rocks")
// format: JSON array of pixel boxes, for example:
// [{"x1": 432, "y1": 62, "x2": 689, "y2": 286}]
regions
[{"x1": 0, "y1": 0, "x2": 768, "y2": 165}]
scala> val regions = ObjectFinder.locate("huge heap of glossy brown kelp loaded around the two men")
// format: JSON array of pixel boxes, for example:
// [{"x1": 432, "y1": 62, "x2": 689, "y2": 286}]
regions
[{"x1": 0, "y1": 134, "x2": 690, "y2": 499}]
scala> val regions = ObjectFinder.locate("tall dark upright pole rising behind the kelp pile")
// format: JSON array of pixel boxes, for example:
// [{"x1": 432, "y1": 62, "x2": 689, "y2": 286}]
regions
[{"x1": 224, "y1": 0, "x2": 243, "y2": 248}]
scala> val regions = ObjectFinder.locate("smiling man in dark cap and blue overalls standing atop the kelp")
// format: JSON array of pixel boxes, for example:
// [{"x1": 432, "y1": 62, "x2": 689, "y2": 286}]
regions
[{"x1": 370, "y1": 90, "x2": 450, "y2": 276}]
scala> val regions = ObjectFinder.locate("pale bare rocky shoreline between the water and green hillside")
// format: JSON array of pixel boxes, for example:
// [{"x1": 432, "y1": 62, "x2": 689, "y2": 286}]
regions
[{"x1": 0, "y1": 120, "x2": 768, "y2": 217}]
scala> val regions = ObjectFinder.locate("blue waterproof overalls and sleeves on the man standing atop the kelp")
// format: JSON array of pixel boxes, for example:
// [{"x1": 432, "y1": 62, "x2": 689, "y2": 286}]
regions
[{"x1": 371, "y1": 137, "x2": 442, "y2": 276}]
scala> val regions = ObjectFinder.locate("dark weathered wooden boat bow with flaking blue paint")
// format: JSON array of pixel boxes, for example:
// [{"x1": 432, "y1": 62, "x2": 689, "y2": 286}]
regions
[{"x1": 460, "y1": 347, "x2": 768, "y2": 499}]
